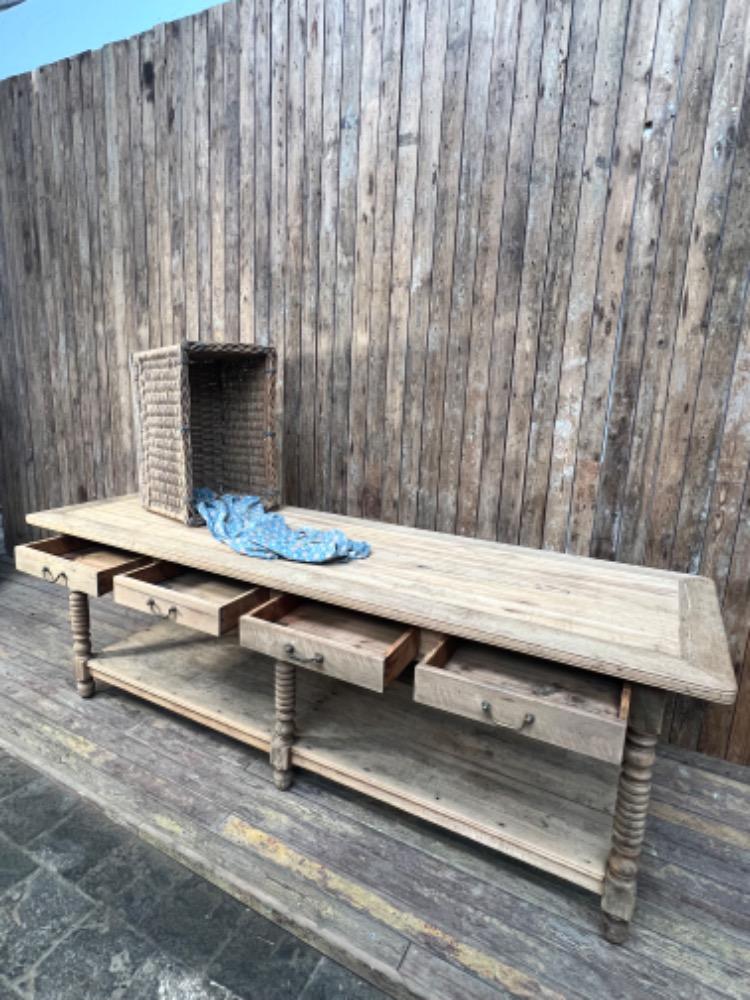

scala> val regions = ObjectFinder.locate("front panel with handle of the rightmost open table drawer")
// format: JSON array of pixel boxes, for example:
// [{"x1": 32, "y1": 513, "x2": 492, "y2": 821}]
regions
[{"x1": 414, "y1": 644, "x2": 627, "y2": 763}]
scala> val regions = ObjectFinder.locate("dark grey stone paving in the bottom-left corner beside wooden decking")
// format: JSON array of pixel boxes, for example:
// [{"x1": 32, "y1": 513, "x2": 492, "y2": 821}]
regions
[{"x1": 0, "y1": 751, "x2": 384, "y2": 1000}]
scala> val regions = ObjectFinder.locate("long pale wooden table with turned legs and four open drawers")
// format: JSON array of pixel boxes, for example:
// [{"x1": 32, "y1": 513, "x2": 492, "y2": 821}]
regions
[{"x1": 17, "y1": 497, "x2": 736, "y2": 942}]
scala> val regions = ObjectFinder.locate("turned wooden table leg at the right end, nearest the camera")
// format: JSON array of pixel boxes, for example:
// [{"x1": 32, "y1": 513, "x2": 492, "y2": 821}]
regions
[{"x1": 602, "y1": 688, "x2": 664, "y2": 944}]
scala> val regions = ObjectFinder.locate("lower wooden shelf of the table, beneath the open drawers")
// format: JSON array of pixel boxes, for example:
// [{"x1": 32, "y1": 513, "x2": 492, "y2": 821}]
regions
[{"x1": 90, "y1": 622, "x2": 618, "y2": 892}]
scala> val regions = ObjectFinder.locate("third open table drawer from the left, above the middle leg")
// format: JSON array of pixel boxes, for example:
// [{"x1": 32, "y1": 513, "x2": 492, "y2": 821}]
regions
[{"x1": 240, "y1": 594, "x2": 419, "y2": 691}]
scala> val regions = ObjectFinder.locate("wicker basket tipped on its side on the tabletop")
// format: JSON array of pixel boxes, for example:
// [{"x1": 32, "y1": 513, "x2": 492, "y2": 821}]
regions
[{"x1": 131, "y1": 342, "x2": 281, "y2": 525}]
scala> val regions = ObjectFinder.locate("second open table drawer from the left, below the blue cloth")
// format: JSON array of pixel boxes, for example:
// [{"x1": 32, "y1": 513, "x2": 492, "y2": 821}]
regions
[{"x1": 115, "y1": 562, "x2": 268, "y2": 635}]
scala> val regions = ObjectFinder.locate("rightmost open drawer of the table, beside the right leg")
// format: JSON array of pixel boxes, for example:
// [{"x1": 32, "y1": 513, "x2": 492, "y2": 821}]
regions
[{"x1": 414, "y1": 639, "x2": 630, "y2": 763}]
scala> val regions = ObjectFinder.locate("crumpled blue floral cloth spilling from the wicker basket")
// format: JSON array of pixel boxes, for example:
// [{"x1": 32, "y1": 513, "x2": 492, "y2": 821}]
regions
[{"x1": 195, "y1": 489, "x2": 370, "y2": 563}]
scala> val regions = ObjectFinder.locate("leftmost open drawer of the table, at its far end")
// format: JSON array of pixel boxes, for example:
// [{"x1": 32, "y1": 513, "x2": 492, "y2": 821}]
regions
[{"x1": 15, "y1": 535, "x2": 146, "y2": 597}]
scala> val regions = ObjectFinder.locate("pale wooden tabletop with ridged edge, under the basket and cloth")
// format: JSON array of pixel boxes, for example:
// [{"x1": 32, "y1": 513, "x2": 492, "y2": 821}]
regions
[{"x1": 27, "y1": 496, "x2": 737, "y2": 704}]
